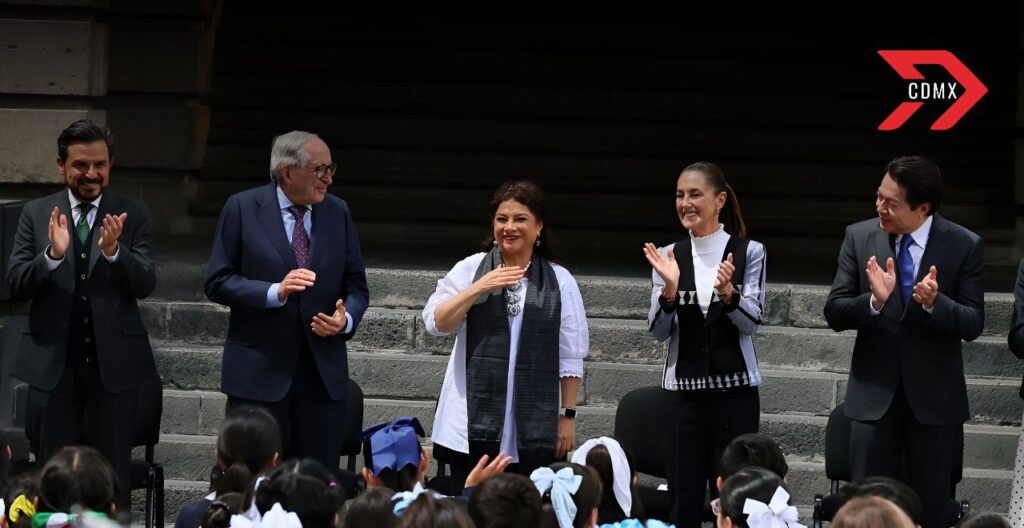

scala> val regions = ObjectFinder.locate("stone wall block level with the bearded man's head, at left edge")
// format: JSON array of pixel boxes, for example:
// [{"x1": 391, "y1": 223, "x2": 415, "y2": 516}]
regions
[{"x1": 0, "y1": 108, "x2": 106, "y2": 183}]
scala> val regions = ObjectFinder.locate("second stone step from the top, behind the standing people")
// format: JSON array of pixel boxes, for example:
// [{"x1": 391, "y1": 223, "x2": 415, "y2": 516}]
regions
[{"x1": 143, "y1": 302, "x2": 1024, "y2": 377}]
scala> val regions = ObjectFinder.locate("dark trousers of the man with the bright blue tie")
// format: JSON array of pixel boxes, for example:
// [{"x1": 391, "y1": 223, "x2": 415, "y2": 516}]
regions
[{"x1": 850, "y1": 386, "x2": 964, "y2": 528}]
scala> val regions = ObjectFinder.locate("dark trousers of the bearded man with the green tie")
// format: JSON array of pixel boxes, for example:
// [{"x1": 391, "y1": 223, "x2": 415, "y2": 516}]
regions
[{"x1": 30, "y1": 359, "x2": 138, "y2": 512}]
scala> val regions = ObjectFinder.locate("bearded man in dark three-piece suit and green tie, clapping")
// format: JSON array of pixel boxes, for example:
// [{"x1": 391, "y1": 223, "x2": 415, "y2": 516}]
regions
[{"x1": 7, "y1": 120, "x2": 157, "y2": 507}]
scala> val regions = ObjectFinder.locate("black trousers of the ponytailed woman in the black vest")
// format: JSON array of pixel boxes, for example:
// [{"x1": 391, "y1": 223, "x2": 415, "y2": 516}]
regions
[{"x1": 666, "y1": 387, "x2": 761, "y2": 528}]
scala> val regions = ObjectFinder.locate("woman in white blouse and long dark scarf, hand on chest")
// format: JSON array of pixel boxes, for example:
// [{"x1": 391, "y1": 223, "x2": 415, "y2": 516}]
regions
[{"x1": 423, "y1": 180, "x2": 590, "y2": 487}]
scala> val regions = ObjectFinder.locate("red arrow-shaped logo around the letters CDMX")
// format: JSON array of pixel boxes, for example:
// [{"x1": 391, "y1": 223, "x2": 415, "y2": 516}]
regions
[{"x1": 879, "y1": 49, "x2": 988, "y2": 130}]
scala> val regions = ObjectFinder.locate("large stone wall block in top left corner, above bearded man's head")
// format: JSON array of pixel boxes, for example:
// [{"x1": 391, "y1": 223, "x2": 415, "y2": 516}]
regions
[{"x1": 0, "y1": 18, "x2": 106, "y2": 95}]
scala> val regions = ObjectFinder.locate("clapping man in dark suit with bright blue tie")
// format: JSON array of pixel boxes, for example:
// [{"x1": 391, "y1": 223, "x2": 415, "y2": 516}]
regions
[{"x1": 825, "y1": 157, "x2": 985, "y2": 528}]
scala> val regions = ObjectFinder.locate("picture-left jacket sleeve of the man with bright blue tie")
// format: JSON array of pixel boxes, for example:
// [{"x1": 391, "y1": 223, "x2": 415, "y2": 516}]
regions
[{"x1": 825, "y1": 226, "x2": 871, "y2": 332}]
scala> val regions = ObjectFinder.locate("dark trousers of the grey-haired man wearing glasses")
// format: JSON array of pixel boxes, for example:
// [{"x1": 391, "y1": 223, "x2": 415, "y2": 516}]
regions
[{"x1": 226, "y1": 341, "x2": 347, "y2": 473}]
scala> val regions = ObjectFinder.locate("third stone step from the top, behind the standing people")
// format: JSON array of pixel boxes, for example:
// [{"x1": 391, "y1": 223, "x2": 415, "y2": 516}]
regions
[{"x1": 157, "y1": 347, "x2": 1021, "y2": 427}]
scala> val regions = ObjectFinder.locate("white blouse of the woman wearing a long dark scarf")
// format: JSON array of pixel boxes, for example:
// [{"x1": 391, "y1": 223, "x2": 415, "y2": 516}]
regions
[{"x1": 423, "y1": 253, "x2": 590, "y2": 463}]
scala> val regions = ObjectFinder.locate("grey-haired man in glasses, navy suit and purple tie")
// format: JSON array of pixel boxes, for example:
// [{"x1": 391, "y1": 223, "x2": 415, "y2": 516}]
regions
[{"x1": 205, "y1": 131, "x2": 370, "y2": 470}]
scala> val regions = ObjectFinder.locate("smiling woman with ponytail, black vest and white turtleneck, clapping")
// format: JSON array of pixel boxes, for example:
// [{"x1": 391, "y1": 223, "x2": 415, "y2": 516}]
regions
[{"x1": 644, "y1": 162, "x2": 765, "y2": 527}]
